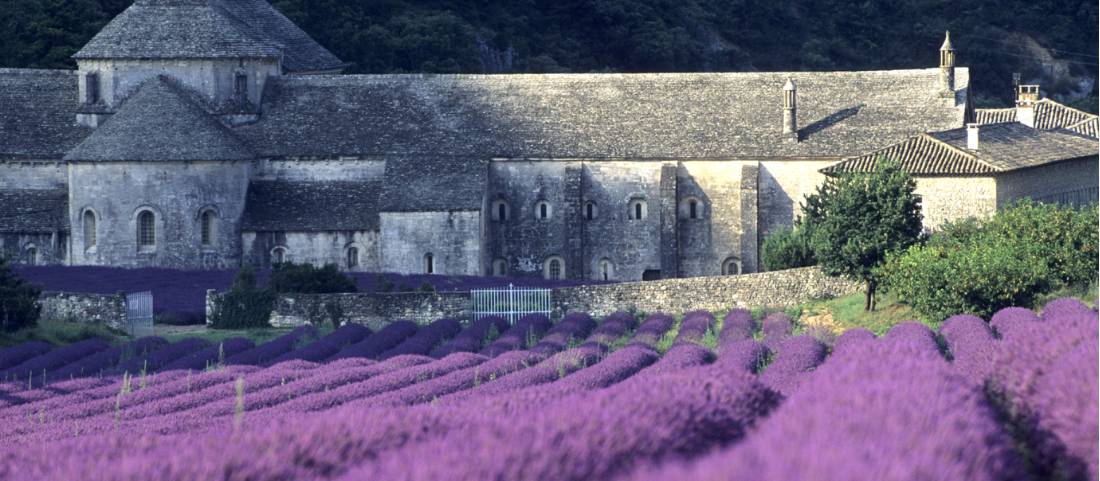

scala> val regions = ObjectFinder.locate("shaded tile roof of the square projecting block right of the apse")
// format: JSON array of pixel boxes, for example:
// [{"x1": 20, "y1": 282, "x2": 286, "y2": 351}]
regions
[{"x1": 380, "y1": 155, "x2": 488, "y2": 212}]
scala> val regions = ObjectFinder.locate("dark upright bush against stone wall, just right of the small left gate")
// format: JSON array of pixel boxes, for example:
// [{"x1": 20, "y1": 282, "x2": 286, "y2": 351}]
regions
[{"x1": 210, "y1": 267, "x2": 275, "y2": 329}]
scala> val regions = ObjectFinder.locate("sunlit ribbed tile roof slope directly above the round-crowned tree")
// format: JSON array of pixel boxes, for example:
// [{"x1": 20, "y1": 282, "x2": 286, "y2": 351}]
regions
[{"x1": 821, "y1": 129, "x2": 998, "y2": 175}]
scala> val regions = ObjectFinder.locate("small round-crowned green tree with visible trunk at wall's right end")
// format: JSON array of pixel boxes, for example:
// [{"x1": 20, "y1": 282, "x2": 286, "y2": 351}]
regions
[{"x1": 802, "y1": 158, "x2": 922, "y2": 310}]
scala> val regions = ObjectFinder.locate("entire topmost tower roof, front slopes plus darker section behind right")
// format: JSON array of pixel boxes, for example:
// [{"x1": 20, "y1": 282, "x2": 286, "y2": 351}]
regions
[{"x1": 74, "y1": 0, "x2": 345, "y2": 72}]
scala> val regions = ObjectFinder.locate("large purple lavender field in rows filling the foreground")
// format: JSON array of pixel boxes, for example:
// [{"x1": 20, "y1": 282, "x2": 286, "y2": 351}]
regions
[{"x1": 0, "y1": 299, "x2": 1100, "y2": 481}]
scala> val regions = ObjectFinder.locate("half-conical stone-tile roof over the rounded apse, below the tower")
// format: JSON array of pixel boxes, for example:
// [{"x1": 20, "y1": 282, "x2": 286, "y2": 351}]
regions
[{"x1": 65, "y1": 76, "x2": 255, "y2": 162}]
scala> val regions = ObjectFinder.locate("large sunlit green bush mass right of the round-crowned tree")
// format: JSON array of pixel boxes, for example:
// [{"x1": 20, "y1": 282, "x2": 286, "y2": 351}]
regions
[{"x1": 880, "y1": 201, "x2": 1098, "y2": 323}]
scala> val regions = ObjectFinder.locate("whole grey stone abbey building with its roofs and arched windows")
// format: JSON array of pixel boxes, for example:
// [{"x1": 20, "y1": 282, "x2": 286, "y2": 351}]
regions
[{"x1": 0, "y1": 0, "x2": 1097, "y2": 280}]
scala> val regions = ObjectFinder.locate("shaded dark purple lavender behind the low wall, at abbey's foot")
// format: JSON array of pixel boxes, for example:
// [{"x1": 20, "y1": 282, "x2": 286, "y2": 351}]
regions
[{"x1": 15, "y1": 265, "x2": 598, "y2": 324}]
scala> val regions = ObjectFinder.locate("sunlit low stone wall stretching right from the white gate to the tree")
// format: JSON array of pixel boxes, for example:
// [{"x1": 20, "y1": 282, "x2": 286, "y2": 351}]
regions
[{"x1": 553, "y1": 267, "x2": 861, "y2": 316}]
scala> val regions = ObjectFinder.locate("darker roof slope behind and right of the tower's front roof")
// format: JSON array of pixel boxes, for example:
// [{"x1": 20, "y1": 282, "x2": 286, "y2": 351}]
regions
[{"x1": 211, "y1": 0, "x2": 348, "y2": 73}]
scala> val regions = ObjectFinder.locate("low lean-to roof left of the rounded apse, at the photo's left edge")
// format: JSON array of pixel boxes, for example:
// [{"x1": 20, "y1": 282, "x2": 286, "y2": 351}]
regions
[{"x1": 0, "y1": 189, "x2": 69, "y2": 233}]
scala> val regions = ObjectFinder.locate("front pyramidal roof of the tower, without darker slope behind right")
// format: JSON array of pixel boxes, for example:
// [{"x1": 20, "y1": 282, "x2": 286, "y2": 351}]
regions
[{"x1": 73, "y1": 0, "x2": 283, "y2": 59}]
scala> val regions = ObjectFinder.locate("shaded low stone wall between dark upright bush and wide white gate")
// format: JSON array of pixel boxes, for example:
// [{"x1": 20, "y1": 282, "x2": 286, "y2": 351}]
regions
[{"x1": 271, "y1": 293, "x2": 470, "y2": 330}]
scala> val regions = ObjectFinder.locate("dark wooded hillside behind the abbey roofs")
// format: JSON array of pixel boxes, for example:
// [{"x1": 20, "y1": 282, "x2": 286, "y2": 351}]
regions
[{"x1": 0, "y1": 0, "x2": 1098, "y2": 112}]
